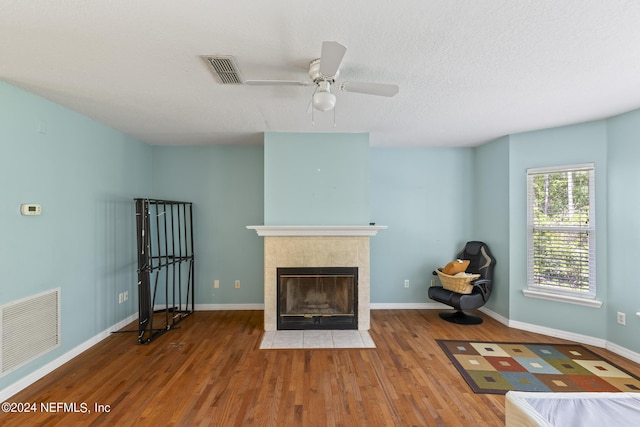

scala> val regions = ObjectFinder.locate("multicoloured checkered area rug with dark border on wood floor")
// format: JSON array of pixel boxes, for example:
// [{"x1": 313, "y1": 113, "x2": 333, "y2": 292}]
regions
[{"x1": 436, "y1": 340, "x2": 640, "y2": 394}]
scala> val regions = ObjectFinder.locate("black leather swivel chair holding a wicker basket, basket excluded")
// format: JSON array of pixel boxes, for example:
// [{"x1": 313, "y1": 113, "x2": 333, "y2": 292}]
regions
[{"x1": 429, "y1": 242, "x2": 496, "y2": 325}]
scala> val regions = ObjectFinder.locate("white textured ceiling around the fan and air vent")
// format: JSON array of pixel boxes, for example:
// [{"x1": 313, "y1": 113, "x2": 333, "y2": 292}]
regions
[{"x1": 0, "y1": 0, "x2": 640, "y2": 146}]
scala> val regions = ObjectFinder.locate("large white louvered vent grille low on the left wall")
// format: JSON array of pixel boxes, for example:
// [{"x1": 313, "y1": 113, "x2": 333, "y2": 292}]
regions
[{"x1": 0, "y1": 288, "x2": 60, "y2": 376}]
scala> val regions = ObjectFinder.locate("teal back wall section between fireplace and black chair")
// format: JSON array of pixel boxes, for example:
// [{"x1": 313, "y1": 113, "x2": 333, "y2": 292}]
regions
[{"x1": 370, "y1": 148, "x2": 473, "y2": 303}]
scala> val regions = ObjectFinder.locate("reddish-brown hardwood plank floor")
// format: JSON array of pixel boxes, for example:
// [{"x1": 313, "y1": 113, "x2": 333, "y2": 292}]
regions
[{"x1": 0, "y1": 310, "x2": 640, "y2": 426}]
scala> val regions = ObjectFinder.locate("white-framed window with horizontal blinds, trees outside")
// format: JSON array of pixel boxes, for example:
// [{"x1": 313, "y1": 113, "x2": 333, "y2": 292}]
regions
[{"x1": 527, "y1": 164, "x2": 596, "y2": 299}]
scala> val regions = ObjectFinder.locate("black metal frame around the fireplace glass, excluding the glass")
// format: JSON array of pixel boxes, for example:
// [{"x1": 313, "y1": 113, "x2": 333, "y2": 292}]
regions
[{"x1": 276, "y1": 267, "x2": 358, "y2": 330}]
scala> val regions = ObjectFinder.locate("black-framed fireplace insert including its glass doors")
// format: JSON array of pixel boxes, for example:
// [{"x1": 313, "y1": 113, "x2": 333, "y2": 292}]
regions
[{"x1": 277, "y1": 267, "x2": 358, "y2": 329}]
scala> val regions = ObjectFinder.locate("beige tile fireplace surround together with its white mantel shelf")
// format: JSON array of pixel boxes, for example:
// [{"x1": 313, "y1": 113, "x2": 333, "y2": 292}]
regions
[{"x1": 247, "y1": 225, "x2": 387, "y2": 331}]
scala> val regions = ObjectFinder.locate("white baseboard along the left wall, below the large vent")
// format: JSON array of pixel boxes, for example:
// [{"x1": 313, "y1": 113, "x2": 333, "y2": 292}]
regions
[{"x1": 0, "y1": 313, "x2": 138, "y2": 402}]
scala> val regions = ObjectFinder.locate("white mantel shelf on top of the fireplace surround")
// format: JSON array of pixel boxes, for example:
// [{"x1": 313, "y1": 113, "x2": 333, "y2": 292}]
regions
[{"x1": 247, "y1": 225, "x2": 388, "y2": 237}]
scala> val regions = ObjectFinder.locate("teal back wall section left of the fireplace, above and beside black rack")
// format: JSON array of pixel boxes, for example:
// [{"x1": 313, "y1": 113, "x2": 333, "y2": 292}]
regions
[{"x1": 151, "y1": 146, "x2": 264, "y2": 304}]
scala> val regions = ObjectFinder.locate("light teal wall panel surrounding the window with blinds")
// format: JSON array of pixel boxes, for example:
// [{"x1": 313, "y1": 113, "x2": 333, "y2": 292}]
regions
[{"x1": 509, "y1": 120, "x2": 608, "y2": 339}]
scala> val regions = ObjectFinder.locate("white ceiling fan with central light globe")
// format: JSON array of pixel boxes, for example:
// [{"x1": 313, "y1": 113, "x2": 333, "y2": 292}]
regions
[{"x1": 244, "y1": 41, "x2": 399, "y2": 112}]
